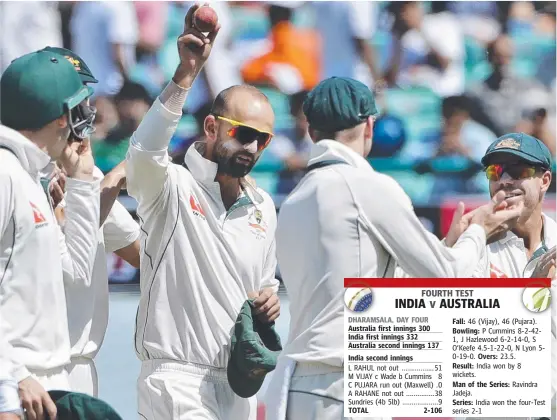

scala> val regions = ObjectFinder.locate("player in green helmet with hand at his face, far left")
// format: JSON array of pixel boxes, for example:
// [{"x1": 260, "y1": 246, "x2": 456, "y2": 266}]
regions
[{"x1": 0, "y1": 51, "x2": 99, "y2": 420}]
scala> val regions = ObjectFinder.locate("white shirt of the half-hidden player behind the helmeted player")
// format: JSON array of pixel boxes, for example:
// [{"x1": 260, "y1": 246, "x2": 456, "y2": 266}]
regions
[{"x1": 64, "y1": 167, "x2": 139, "y2": 359}]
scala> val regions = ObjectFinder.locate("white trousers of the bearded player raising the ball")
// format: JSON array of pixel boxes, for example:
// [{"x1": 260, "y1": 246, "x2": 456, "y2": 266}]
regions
[{"x1": 137, "y1": 360, "x2": 257, "y2": 420}]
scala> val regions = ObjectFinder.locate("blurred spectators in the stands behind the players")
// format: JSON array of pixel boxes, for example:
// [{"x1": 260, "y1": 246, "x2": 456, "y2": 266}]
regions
[{"x1": 0, "y1": 1, "x2": 556, "y2": 225}]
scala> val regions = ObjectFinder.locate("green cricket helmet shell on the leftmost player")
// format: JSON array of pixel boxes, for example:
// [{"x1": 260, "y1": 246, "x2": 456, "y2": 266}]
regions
[{"x1": 0, "y1": 51, "x2": 93, "y2": 130}]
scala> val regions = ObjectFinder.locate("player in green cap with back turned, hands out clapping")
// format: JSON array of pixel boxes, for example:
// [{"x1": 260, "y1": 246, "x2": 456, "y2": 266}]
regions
[{"x1": 267, "y1": 77, "x2": 520, "y2": 420}]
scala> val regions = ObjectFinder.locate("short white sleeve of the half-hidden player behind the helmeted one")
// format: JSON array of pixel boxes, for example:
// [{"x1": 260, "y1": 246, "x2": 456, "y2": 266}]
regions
[{"x1": 103, "y1": 200, "x2": 139, "y2": 252}]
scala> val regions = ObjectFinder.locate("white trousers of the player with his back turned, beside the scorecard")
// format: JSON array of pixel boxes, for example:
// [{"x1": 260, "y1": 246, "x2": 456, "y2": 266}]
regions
[{"x1": 286, "y1": 363, "x2": 384, "y2": 420}]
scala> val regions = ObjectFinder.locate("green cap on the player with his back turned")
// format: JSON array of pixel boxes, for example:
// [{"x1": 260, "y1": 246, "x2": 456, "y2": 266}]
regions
[{"x1": 303, "y1": 77, "x2": 377, "y2": 133}]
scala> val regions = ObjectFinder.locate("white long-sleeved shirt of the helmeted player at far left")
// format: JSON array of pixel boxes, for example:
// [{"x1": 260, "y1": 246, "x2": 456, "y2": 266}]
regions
[{"x1": 0, "y1": 125, "x2": 99, "y2": 382}]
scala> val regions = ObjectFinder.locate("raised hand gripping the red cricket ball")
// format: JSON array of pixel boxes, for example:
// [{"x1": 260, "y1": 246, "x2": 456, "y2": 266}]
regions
[{"x1": 173, "y1": 4, "x2": 220, "y2": 89}]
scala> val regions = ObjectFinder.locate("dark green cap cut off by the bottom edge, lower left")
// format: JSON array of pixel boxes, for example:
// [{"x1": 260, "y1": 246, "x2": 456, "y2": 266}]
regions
[{"x1": 48, "y1": 391, "x2": 122, "y2": 420}]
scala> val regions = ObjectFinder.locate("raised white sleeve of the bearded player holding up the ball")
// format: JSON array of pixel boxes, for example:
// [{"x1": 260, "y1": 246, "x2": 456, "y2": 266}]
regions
[{"x1": 126, "y1": 98, "x2": 182, "y2": 206}]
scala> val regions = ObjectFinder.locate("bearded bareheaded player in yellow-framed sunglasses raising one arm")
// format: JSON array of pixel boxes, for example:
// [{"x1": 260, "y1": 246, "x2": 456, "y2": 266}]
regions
[{"x1": 126, "y1": 5, "x2": 280, "y2": 420}]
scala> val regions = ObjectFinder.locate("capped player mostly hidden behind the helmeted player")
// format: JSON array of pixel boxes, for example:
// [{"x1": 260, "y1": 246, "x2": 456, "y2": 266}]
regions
[{"x1": 37, "y1": 47, "x2": 139, "y2": 397}]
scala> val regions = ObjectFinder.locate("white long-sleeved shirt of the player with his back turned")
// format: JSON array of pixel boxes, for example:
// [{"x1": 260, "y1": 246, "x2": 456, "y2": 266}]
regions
[{"x1": 277, "y1": 140, "x2": 486, "y2": 367}]
